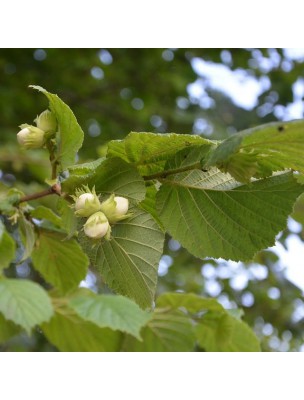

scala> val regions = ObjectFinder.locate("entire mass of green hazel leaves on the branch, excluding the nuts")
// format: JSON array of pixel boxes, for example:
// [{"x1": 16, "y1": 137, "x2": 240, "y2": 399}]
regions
[{"x1": 0, "y1": 87, "x2": 304, "y2": 351}]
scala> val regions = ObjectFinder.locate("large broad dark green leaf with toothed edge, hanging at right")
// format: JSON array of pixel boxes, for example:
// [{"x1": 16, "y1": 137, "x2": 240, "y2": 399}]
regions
[{"x1": 156, "y1": 169, "x2": 304, "y2": 261}]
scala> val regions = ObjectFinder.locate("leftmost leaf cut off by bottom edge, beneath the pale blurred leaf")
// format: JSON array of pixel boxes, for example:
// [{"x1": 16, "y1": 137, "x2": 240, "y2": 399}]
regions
[{"x1": 41, "y1": 308, "x2": 121, "y2": 352}]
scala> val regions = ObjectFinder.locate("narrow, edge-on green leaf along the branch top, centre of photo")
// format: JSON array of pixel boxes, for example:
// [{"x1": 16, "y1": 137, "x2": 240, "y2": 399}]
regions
[{"x1": 108, "y1": 132, "x2": 214, "y2": 175}]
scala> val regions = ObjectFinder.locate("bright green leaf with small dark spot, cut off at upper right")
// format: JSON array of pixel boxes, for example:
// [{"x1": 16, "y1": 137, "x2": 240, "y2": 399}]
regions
[{"x1": 207, "y1": 120, "x2": 304, "y2": 182}]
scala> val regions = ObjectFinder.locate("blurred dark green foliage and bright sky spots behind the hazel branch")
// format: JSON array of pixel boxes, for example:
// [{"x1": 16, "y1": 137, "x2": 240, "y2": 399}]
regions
[{"x1": 0, "y1": 49, "x2": 304, "y2": 351}]
